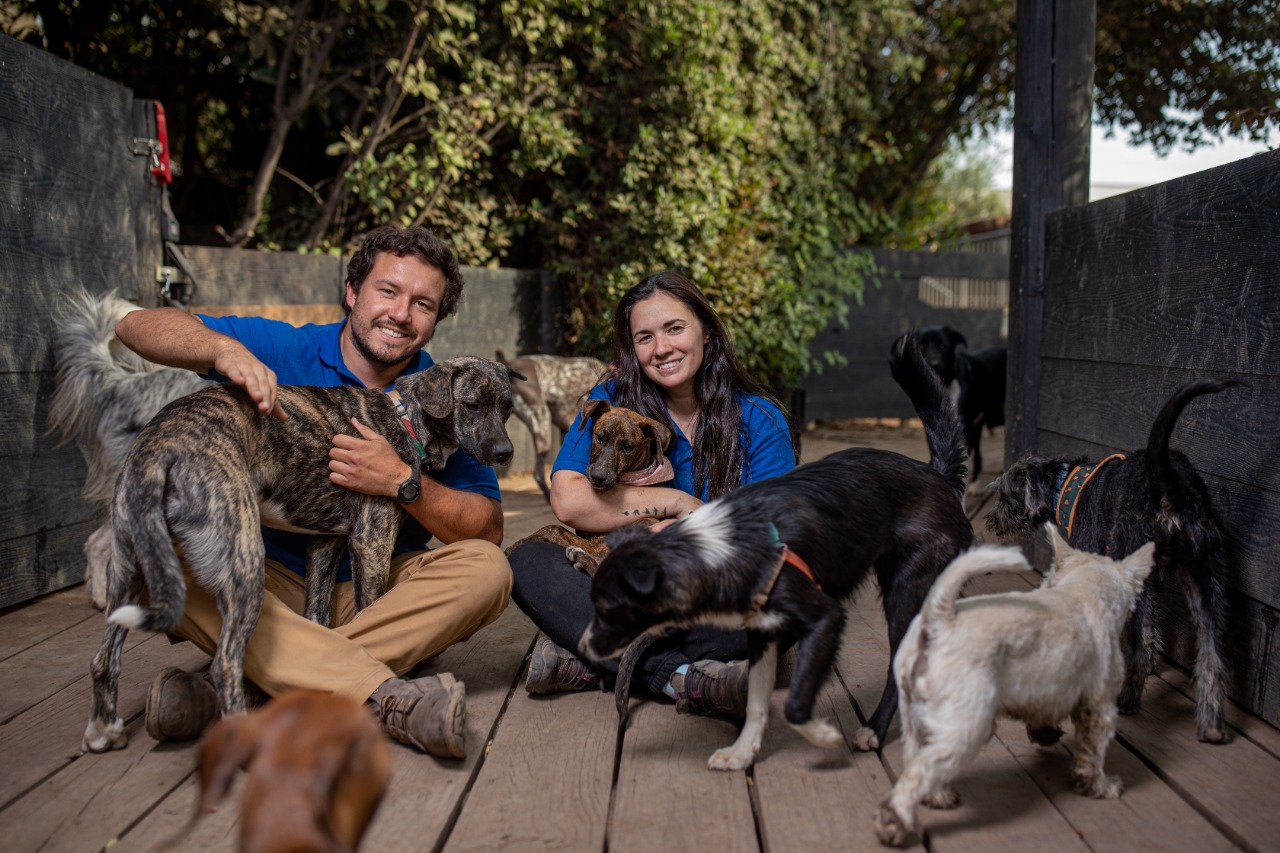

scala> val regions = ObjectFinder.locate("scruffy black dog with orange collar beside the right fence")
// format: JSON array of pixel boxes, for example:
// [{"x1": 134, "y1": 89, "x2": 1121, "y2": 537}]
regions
[{"x1": 987, "y1": 379, "x2": 1240, "y2": 743}]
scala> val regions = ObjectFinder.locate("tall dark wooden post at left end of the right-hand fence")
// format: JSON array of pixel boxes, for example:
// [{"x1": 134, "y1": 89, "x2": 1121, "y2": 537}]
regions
[{"x1": 1005, "y1": 0, "x2": 1097, "y2": 466}]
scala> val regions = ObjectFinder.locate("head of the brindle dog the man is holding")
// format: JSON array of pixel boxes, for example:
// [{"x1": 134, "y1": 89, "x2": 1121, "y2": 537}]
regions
[{"x1": 422, "y1": 356, "x2": 525, "y2": 465}]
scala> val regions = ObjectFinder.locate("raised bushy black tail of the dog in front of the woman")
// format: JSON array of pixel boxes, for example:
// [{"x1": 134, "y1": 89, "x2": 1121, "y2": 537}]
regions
[{"x1": 888, "y1": 332, "x2": 969, "y2": 501}]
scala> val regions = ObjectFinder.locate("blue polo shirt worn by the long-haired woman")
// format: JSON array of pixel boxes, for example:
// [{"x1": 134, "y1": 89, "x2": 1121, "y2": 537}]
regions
[{"x1": 552, "y1": 380, "x2": 796, "y2": 501}]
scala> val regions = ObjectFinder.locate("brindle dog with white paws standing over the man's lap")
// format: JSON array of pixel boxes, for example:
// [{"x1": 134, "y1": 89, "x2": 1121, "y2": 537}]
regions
[{"x1": 84, "y1": 357, "x2": 524, "y2": 752}]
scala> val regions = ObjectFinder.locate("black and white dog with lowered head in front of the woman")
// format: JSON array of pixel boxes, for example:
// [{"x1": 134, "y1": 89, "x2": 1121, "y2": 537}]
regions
[{"x1": 579, "y1": 333, "x2": 973, "y2": 770}]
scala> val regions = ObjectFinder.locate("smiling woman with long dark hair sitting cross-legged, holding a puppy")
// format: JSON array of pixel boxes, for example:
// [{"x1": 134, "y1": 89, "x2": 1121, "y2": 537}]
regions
[{"x1": 509, "y1": 269, "x2": 796, "y2": 717}]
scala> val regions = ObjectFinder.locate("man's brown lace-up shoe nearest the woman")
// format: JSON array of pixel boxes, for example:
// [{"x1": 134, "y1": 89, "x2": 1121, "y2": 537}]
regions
[{"x1": 369, "y1": 672, "x2": 467, "y2": 758}]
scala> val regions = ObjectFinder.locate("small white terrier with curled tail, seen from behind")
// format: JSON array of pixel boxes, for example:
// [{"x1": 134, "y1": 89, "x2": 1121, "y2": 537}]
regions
[{"x1": 874, "y1": 524, "x2": 1155, "y2": 845}]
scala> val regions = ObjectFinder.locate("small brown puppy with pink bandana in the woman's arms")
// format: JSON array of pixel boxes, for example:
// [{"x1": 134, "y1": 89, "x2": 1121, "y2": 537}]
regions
[{"x1": 507, "y1": 400, "x2": 675, "y2": 576}]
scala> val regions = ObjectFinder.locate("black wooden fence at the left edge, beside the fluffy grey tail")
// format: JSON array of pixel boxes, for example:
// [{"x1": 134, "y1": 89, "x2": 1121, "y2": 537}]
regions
[{"x1": 0, "y1": 36, "x2": 161, "y2": 606}]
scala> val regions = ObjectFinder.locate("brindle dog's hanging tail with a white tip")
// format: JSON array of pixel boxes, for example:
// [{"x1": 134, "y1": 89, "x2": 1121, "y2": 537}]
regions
[{"x1": 106, "y1": 456, "x2": 187, "y2": 634}]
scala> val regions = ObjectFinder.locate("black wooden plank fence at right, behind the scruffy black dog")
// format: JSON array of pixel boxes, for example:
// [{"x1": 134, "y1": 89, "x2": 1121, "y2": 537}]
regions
[{"x1": 1033, "y1": 151, "x2": 1280, "y2": 724}]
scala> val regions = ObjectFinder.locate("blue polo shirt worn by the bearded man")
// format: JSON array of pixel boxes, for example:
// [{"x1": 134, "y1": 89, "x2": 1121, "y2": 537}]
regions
[{"x1": 196, "y1": 314, "x2": 502, "y2": 580}]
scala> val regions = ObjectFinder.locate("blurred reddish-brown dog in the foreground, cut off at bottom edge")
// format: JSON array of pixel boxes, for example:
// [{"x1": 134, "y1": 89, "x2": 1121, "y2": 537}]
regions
[{"x1": 192, "y1": 690, "x2": 392, "y2": 853}]
